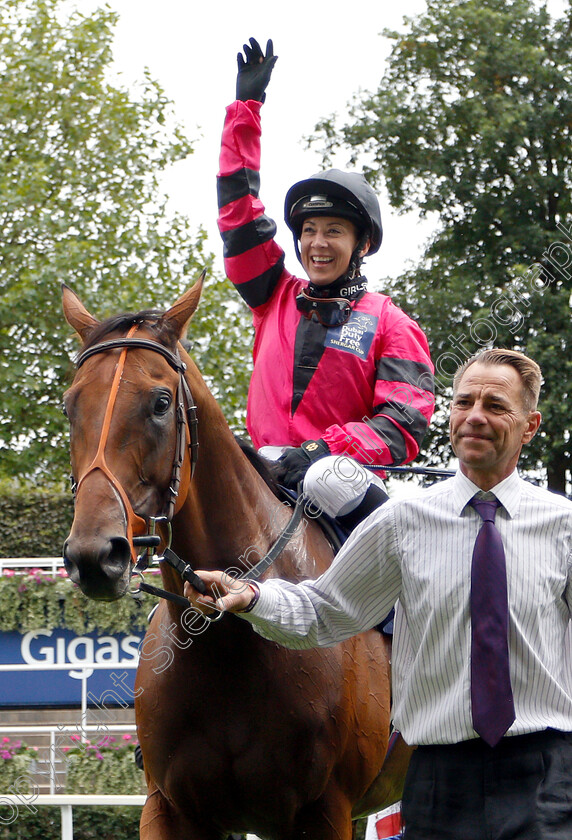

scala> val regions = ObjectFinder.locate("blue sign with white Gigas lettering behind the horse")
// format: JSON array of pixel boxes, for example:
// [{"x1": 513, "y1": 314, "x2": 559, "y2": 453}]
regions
[{"x1": 0, "y1": 628, "x2": 144, "y2": 709}]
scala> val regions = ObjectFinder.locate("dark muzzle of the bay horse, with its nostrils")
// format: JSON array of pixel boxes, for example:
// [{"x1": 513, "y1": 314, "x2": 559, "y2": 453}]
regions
[{"x1": 63, "y1": 534, "x2": 131, "y2": 601}]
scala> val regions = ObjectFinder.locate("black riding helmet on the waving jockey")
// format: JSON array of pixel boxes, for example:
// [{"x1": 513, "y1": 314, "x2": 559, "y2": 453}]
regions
[{"x1": 284, "y1": 169, "x2": 383, "y2": 276}]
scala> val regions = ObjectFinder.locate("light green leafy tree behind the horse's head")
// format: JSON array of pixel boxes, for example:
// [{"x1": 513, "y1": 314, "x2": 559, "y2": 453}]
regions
[{"x1": 0, "y1": 0, "x2": 250, "y2": 480}]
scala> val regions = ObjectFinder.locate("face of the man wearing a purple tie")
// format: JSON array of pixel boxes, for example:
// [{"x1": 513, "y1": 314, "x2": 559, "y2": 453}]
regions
[{"x1": 449, "y1": 362, "x2": 540, "y2": 490}]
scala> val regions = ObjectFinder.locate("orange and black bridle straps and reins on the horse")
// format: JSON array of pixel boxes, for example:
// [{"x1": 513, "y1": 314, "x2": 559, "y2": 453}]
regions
[{"x1": 73, "y1": 332, "x2": 303, "y2": 621}]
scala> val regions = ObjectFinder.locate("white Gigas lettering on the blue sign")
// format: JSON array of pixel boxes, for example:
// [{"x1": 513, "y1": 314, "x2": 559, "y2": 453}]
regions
[{"x1": 20, "y1": 630, "x2": 141, "y2": 665}]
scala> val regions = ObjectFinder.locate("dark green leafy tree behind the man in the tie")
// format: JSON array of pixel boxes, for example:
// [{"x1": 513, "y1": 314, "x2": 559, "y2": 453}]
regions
[{"x1": 313, "y1": 0, "x2": 572, "y2": 492}]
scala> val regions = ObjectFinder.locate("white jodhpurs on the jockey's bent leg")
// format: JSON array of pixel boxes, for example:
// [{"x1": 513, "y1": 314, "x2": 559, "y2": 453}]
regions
[{"x1": 303, "y1": 455, "x2": 387, "y2": 517}]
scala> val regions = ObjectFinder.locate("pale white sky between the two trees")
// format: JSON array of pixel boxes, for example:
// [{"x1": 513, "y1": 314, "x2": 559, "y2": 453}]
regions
[{"x1": 66, "y1": 0, "x2": 432, "y2": 282}]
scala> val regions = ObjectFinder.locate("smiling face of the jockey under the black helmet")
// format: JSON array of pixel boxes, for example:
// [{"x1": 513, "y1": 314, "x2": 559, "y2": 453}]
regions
[{"x1": 300, "y1": 216, "x2": 368, "y2": 286}]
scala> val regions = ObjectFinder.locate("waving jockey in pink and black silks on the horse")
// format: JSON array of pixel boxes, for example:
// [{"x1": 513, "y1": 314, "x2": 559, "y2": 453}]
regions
[{"x1": 218, "y1": 38, "x2": 434, "y2": 529}]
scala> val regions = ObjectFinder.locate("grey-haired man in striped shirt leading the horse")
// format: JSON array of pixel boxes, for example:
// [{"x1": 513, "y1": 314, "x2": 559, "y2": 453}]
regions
[{"x1": 187, "y1": 350, "x2": 572, "y2": 840}]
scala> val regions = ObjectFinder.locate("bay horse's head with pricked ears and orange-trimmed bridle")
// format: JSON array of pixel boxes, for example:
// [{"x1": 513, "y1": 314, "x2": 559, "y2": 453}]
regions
[{"x1": 63, "y1": 277, "x2": 202, "y2": 601}]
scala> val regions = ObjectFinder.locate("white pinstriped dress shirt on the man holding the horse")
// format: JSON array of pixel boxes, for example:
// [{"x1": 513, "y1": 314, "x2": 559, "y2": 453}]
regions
[{"x1": 244, "y1": 471, "x2": 572, "y2": 744}]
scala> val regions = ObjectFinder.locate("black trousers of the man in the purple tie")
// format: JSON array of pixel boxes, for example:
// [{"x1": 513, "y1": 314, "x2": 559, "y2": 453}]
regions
[{"x1": 402, "y1": 729, "x2": 572, "y2": 840}]
